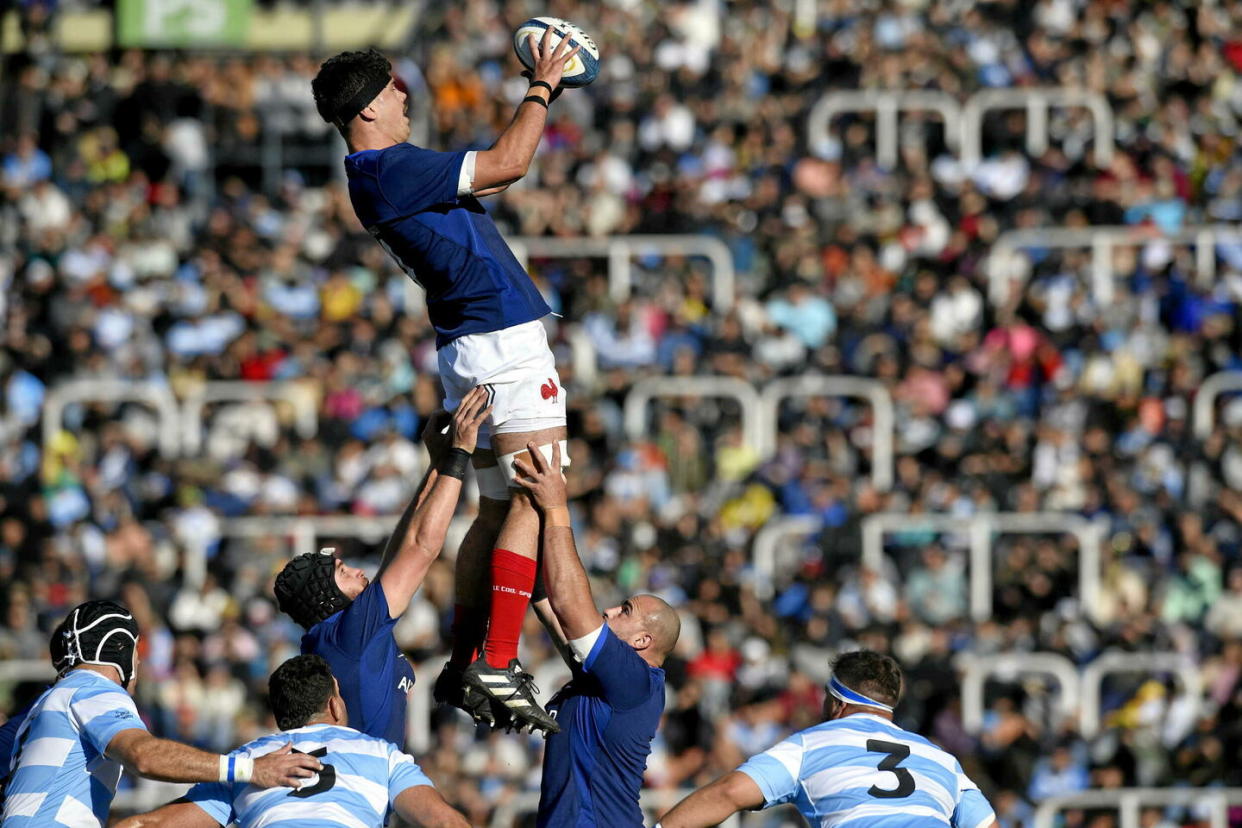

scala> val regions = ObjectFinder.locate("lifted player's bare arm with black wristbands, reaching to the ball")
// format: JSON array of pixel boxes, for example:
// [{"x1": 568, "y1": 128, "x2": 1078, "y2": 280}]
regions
[{"x1": 473, "y1": 26, "x2": 580, "y2": 196}]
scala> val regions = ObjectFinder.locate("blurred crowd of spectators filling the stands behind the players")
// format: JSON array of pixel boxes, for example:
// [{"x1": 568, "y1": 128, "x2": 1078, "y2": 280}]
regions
[{"x1": 0, "y1": 0, "x2": 1242, "y2": 828}]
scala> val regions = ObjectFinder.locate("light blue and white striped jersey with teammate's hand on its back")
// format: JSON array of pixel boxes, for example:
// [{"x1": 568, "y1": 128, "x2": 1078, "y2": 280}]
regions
[{"x1": 186, "y1": 725, "x2": 435, "y2": 828}]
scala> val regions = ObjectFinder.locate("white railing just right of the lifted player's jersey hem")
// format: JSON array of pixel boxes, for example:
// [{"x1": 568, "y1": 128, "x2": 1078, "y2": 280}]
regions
[{"x1": 505, "y1": 235, "x2": 737, "y2": 312}]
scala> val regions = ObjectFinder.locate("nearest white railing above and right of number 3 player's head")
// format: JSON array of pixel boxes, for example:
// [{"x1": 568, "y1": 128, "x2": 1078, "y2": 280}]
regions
[{"x1": 862, "y1": 511, "x2": 1102, "y2": 621}]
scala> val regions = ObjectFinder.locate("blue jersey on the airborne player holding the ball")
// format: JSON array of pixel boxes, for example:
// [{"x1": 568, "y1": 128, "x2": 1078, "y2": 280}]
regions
[{"x1": 345, "y1": 143, "x2": 551, "y2": 348}]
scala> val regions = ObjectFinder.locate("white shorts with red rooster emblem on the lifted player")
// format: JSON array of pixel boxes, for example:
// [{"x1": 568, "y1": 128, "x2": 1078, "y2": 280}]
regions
[{"x1": 436, "y1": 319, "x2": 565, "y2": 448}]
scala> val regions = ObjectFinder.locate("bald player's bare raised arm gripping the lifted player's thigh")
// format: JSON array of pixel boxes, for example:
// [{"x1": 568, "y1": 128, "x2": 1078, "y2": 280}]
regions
[{"x1": 514, "y1": 443, "x2": 604, "y2": 641}]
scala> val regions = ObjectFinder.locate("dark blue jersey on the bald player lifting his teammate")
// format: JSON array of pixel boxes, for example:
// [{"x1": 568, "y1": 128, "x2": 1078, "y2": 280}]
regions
[{"x1": 535, "y1": 624, "x2": 664, "y2": 828}]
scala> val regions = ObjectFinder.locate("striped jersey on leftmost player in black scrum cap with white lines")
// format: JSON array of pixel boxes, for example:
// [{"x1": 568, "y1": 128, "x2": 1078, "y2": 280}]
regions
[{"x1": 4, "y1": 669, "x2": 147, "y2": 828}]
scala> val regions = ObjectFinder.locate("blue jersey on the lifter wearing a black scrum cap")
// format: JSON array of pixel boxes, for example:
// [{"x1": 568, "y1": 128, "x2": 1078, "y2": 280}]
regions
[{"x1": 302, "y1": 578, "x2": 414, "y2": 746}]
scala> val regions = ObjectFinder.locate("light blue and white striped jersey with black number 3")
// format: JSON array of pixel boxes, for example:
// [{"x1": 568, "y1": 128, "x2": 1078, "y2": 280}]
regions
[{"x1": 738, "y1": 714, "x2": 994, "y2": 828}]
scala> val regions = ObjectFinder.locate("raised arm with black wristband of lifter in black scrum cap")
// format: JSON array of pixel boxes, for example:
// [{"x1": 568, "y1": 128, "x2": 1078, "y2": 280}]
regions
[{"x1": 378, "y1": 387, "x2": 492, "y2": 618}]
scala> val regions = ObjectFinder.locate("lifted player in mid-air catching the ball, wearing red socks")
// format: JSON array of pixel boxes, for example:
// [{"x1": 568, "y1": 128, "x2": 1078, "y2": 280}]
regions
[{"x1": 312, "y1": 29, "x2": 578, "y2": 730}]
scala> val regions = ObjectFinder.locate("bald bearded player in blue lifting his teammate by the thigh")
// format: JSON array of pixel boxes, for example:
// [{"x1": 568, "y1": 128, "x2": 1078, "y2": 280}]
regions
[{"x1": 514, "y1": 443, "x2": 681, "y2": 828}]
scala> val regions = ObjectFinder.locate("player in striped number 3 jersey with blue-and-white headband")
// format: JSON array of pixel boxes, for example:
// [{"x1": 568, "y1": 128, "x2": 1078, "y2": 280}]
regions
[{"x1": 656, "y1": 650, "x2": 996, "y2": 828}]
